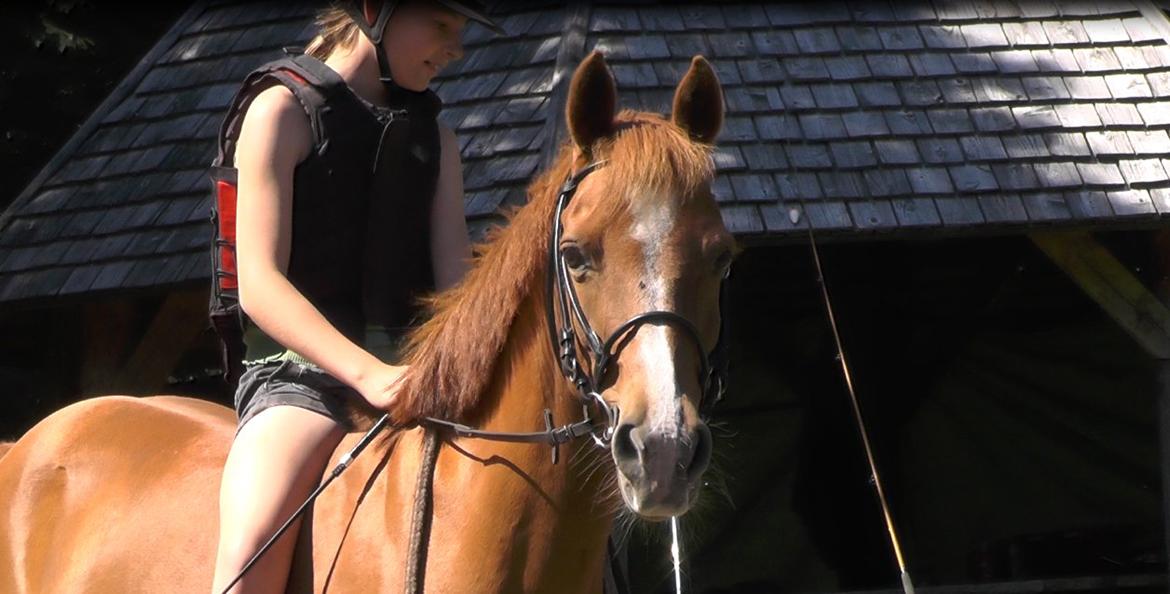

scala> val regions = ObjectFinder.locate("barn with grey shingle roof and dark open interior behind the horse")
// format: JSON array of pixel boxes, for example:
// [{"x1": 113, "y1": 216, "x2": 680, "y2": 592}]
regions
[{"x1": 0, "y1": 0, "x2": 1170, "y2": 593}]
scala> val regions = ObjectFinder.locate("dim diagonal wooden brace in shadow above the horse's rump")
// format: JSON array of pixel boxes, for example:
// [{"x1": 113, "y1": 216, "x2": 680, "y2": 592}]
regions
[{"x1": 113, "y1": 291, "x2": 207, "y2": 394}]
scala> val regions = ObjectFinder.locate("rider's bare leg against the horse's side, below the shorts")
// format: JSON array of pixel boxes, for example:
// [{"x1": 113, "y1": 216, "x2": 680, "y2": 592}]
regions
[{"x1": 212, "y1": 406, "x2": 345, "y2": 594}]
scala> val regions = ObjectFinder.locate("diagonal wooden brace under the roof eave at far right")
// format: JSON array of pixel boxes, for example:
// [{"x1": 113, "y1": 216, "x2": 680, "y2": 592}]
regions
[{"x1": 1030, "y1": 232, "x2": 1170, "y2": 360}]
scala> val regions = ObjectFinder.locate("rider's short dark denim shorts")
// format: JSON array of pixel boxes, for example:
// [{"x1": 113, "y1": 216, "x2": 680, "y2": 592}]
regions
[{"x1": 235, "y1": 361, "x2": 362, "y2": 434}]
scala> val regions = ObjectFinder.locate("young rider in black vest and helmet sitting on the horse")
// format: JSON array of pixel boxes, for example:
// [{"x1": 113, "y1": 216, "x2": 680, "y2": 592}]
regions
[{"x1": 212, "y1": 1, "x2": 495, "y2": 594}]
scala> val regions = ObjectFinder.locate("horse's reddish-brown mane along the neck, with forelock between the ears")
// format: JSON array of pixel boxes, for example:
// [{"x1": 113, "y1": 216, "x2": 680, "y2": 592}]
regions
[{"x1": 400, "y1": 111, "x2": 714, "y2": 420}]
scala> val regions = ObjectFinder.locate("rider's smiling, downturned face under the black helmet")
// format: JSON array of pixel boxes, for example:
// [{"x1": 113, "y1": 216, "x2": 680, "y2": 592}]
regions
[{"x1": 381, "y1": 1, "x2": 467, "y2": 91}]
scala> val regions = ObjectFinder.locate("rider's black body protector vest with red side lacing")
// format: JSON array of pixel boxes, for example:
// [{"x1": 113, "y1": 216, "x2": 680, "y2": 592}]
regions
[{"x1": 211, "y1": 55, "x2": 441, "y2": 386}]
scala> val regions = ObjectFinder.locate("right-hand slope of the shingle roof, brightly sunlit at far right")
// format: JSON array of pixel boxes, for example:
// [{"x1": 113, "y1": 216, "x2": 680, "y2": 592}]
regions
[{"x1": 590, "y1": 1, "x2": 1170, "y2": 237}]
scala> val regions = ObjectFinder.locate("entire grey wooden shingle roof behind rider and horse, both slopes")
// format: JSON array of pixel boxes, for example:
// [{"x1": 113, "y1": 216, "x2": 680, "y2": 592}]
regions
[{"x1": 0, "y1": 0, "x2": 1170, "y2": 303}]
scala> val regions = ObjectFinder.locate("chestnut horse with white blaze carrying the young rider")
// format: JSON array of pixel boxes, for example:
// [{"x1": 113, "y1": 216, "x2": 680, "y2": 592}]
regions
[{"x1": 0, "y1": 53, "x2": 732, "y2": 594}]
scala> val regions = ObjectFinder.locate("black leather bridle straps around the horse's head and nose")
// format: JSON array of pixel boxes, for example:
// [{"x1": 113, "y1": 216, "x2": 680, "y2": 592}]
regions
[{"x1": 545, "y1": 161, "x2": 727, "y2": 448}]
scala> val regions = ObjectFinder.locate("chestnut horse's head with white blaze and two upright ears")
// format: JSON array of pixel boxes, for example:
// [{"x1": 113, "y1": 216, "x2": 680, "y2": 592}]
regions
[{"x1": 559, "y1": 53, "x2": 734, "y2": 519}]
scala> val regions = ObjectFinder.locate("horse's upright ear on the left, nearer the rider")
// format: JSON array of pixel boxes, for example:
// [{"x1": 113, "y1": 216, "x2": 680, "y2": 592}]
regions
[{"x1": 565, "y1": 50, "x2": 618, "y2": 154}]
